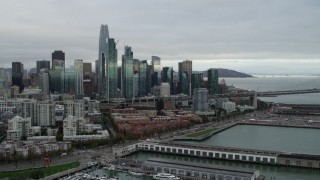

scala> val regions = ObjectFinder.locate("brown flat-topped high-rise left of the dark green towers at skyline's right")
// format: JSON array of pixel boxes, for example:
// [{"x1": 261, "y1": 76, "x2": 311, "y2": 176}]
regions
[{"x1": 179, "y1": 60, "x2": 192, "y2": 95}]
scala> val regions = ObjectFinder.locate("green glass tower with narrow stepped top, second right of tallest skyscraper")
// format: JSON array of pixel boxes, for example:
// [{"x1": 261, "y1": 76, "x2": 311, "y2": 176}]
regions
[{"x1": 121, "y1": 46, "x2": 133, "y2": 99}]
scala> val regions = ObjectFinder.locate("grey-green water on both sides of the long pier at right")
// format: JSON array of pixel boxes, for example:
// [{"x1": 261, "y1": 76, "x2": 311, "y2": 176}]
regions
[{"x1": 127, "y1": 125, "x2": 320, "y2": 180}]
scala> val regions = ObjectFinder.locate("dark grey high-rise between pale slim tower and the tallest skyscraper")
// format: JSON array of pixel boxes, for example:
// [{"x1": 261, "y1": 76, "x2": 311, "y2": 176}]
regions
[{"x1": 83, "y1": 63, "x2": 93, "y2": 95}]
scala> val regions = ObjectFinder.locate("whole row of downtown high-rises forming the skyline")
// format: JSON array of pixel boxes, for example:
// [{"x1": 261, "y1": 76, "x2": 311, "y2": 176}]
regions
[{"x1": 0, "y1": 25, "x2": 220, "y2": 100}]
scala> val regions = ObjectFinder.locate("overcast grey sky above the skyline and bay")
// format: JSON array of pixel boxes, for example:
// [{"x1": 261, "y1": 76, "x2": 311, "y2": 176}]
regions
[{"x1": 0, "y1": 0, "x2": 320, "y2": 74}]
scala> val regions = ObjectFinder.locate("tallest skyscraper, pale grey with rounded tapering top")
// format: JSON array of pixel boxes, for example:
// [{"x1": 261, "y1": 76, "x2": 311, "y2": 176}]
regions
[{"x1": 97, "y1": 24, "x2": 109, "y2": 97}]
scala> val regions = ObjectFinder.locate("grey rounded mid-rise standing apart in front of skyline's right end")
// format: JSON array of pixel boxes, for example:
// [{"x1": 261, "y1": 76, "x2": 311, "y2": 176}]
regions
[{"x1": 193, "y1": 88, "x2": 209, "y2": 113}]
